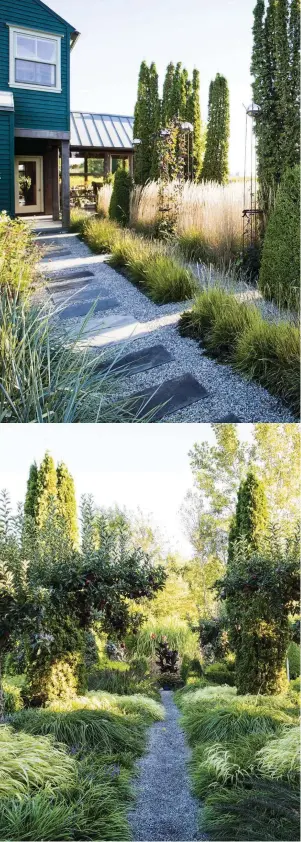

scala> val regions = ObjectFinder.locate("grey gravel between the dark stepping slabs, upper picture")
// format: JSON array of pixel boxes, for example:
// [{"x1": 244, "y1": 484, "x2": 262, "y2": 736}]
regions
[{"x1": 34, "y1": 228, "x2": 296, "y2": 423}]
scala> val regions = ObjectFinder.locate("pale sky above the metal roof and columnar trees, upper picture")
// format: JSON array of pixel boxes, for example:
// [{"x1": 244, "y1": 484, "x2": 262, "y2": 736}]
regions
[{"x1": 48, "y1": 0, "x2": 255, "y2": 175}]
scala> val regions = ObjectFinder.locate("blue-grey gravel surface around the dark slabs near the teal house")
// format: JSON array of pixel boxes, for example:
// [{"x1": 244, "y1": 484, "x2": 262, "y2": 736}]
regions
[{"x1": 34, "y1": 226, "x2": 296, "y2": 423}]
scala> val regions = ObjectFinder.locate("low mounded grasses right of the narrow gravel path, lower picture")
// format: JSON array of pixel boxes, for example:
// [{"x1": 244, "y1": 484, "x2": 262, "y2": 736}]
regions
[{"x1": 176, "y1": 685, "x2": 300, "y2": 842}]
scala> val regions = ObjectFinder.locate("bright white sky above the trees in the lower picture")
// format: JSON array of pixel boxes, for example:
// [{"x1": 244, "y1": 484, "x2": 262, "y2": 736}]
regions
[{"x1": 0, "y1": 424, "x2": 252, "y2": 557}]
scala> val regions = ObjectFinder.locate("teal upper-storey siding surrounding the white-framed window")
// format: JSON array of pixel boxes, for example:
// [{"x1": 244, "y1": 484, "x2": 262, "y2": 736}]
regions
[{"x1": 0, "y1": 0, "x2": 73, "y2": 132}]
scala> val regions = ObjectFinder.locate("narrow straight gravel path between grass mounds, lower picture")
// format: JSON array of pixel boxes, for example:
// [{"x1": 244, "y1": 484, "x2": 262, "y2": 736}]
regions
[{"x1": 129, "y1": 690, "x2": 207, "y2": 842}]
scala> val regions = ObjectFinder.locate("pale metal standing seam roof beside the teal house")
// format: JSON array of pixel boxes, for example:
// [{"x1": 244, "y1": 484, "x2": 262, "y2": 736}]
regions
[{"x1": 70, "y1": 111, "x2": 134, "y2": 150}]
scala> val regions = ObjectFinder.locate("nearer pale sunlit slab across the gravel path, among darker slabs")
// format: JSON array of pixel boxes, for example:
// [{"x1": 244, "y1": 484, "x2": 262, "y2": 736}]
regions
[{"x1": 67, "y1": 313, "x2": 141, "y2": 348}]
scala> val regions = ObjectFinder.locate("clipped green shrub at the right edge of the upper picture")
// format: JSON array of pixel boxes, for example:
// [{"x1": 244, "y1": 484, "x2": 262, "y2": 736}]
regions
[{"x1": 259, "y1": 166, "x2": 300, "y2": 308}]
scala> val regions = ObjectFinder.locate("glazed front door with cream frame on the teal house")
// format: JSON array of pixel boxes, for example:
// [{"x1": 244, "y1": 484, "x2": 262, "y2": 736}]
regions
[{"x1": 15, "y1": 155, "x2": 44, "y2": 213}]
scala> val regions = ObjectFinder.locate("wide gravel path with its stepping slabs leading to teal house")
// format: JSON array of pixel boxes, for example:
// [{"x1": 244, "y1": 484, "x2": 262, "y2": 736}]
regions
[{"x1": 36, "y1": 223, "x2": 295, "y2": 423}]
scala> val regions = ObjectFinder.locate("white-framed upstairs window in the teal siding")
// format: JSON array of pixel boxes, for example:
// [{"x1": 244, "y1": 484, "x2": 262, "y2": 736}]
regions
[{"x1": 9, "y1": 26, "x2": 62, "y2": 93}]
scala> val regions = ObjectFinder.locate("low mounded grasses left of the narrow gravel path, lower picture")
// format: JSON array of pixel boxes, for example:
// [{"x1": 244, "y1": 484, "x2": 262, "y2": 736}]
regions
[{"x1": 0, "y1": 688, "x2": 164, "y2": 842}]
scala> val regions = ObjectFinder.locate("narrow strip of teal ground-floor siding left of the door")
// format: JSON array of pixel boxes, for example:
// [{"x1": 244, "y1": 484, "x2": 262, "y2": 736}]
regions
[{"x1": 0, "y1": 109, "x2": 15, "y2": 216}]
